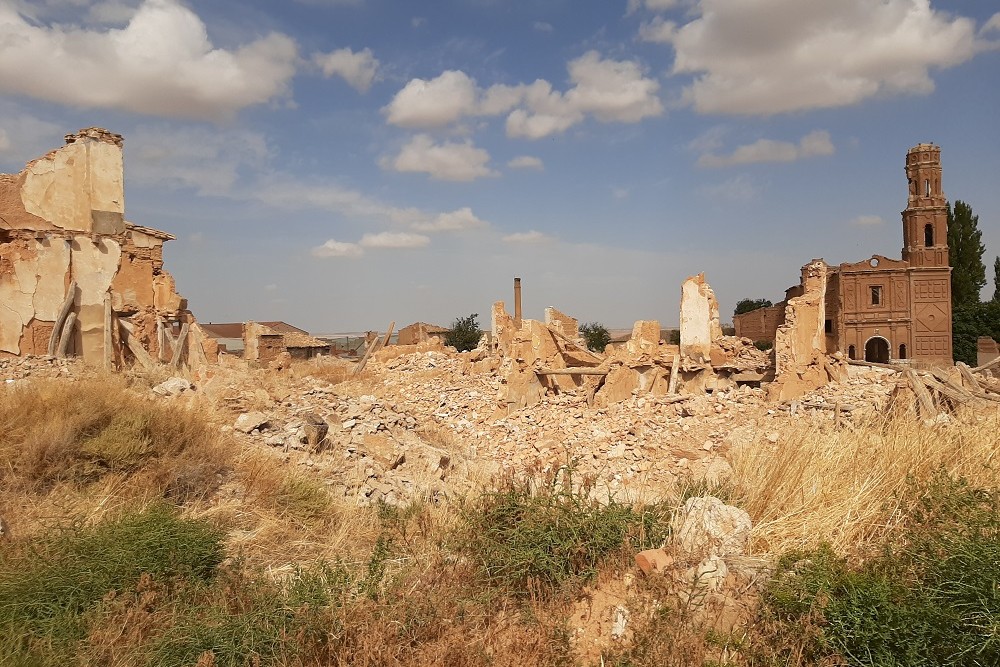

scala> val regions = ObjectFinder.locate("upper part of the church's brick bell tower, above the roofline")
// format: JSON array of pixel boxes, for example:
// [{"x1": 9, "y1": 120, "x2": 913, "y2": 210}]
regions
[{"x1": 903, "y1": 144, "x2": 949, "y2": 267}]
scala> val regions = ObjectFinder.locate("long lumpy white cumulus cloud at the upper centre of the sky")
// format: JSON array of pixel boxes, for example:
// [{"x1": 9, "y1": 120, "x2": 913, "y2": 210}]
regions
[{"x1": 383, "y1": 51, "x2": 663, "y2": 139}]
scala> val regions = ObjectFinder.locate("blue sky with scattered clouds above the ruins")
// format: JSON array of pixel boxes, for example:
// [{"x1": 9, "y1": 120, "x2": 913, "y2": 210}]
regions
[{"x1": 0, "y1": 0, "x2": 1000, "y2": 332}]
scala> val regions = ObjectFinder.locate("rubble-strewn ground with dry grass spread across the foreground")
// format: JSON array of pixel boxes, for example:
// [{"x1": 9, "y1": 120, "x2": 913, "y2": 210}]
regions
[{"x1": 0, "y1": 349, "x2": 1000, "y2": 667}]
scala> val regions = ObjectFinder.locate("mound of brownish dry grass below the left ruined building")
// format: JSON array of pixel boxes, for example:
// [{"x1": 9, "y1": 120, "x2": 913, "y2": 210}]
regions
[{"x1": 0, "y1": 377, "x2": 229, "y2": 502}]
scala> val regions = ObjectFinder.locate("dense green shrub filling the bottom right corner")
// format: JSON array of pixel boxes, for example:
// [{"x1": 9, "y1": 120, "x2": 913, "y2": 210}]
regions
[{"x1": 764, "y1": 474, "x2": 1000, "y2": 667}]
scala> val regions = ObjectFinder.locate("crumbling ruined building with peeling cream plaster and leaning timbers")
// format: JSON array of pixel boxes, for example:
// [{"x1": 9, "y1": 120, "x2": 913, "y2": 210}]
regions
[{"x1": 0, "y1": 128, "x2": 206, "y2": 368}]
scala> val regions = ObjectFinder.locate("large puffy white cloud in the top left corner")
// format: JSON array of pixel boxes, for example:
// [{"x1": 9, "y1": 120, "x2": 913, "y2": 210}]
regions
[{"x1": 0, "y1": 0, "x2": 297, "y2": 118}]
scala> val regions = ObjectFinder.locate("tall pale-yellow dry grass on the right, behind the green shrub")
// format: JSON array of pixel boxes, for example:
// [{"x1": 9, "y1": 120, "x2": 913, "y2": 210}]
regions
[{"x1": 731, "y1": 408, "x2": 1000, "y2": 554}]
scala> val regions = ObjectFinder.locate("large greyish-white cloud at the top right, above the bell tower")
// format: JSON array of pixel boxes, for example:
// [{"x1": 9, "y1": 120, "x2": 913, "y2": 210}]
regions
[{"x1": 672, "y1": 0, "x2": 980, "y2": 115}]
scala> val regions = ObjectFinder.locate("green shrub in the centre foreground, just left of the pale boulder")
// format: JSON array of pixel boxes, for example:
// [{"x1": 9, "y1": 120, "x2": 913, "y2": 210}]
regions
[{"x1": 458, "y1": 482, "x2": 665, "y2": 596}]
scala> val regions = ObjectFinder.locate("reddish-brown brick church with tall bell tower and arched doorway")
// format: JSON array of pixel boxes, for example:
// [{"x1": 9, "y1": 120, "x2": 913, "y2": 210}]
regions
[{"x1": 734, "y1": 144, "x2": 952, "y2": 364}]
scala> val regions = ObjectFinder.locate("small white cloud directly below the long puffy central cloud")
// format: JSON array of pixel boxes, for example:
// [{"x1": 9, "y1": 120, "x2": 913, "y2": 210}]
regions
[{"x1": 382, "y1": 134, "x2": 496, "y2": 181}]
